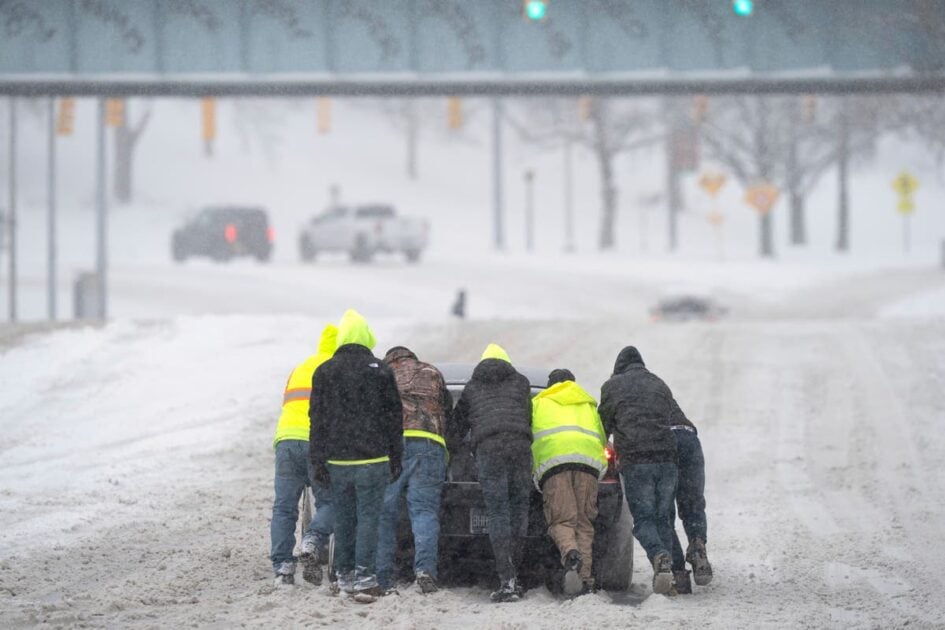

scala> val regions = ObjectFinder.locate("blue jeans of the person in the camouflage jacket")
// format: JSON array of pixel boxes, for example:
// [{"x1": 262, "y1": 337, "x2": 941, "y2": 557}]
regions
[{"x1": 377, "y1": 437, "x2": 446, "y2": 588}]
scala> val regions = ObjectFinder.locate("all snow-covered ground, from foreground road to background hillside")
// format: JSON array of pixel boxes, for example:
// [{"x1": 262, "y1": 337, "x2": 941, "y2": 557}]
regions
[{"x1": 0, "y1": 101, "x2": 945, "y2": 630}]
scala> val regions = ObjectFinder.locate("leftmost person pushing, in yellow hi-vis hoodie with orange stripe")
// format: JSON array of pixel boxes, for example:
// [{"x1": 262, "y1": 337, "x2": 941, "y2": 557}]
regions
[{"x1": 269, "y1": 324, "x2": 338, "y2": 585}]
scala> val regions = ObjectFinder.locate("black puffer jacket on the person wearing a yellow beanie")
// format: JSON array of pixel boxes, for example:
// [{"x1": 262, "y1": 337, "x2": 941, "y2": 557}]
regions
[{"x1": 450, "y1": 359, "x2": 532, "y2": 451}]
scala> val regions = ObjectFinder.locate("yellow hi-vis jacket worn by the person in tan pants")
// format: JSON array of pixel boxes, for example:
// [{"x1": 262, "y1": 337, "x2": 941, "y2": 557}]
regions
[{"x1": 532, "y1": 381, "x2": 607, "y2": 490}]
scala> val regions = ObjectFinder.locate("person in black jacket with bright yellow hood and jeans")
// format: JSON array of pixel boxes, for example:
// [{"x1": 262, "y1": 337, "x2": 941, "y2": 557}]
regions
[{"x1": 309, "y1": 310, "x2": 403, "y2": 602}]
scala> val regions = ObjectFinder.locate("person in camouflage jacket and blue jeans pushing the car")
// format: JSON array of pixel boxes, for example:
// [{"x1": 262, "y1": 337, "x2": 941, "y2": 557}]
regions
[{"x1": 377, "y1": 346, "x2": 453, "y2": 593}]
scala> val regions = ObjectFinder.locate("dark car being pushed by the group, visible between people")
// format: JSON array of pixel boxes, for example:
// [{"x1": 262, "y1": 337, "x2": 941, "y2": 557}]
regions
[{"x1": 397, "y1": 363, "x2": 633, "y2": 592}]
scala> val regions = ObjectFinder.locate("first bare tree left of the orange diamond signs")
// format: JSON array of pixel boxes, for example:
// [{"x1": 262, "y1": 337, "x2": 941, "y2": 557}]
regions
[{"x1": 506, "y1": 98, "x2": 663, "y2": 250}]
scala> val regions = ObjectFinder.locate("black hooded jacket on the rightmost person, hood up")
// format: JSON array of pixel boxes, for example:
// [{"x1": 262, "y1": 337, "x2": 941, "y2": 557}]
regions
[{"x1": 598, "y1": 346, "x2": 681, "y2": 465}]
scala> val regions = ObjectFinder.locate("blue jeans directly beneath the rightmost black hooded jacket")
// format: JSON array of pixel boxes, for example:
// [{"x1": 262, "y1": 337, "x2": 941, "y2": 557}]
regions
[{"x1": 622, "y1": 462, "x2": 676, "y2": 562}]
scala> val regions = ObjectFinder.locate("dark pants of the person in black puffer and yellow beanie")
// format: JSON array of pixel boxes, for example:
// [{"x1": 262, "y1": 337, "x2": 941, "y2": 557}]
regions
[{"x1": 476, "y1": 440, "x2": 532, "y2": 583}]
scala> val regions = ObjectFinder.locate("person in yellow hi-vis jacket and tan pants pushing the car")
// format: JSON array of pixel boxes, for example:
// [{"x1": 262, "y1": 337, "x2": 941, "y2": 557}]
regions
[{"x1": 532, "y1": 369, "x2": 607, "y2": 595}]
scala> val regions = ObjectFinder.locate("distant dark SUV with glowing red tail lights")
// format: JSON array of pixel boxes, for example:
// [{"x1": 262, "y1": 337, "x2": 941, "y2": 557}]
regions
[{"x1": 171, "y1": 206, "x2": 274, "y2": 262}]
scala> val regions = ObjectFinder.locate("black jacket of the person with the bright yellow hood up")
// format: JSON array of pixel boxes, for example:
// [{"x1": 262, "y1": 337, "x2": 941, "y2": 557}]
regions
[{"x1": 309, "y1": 343, "x2": 403, "y2": 467}]
